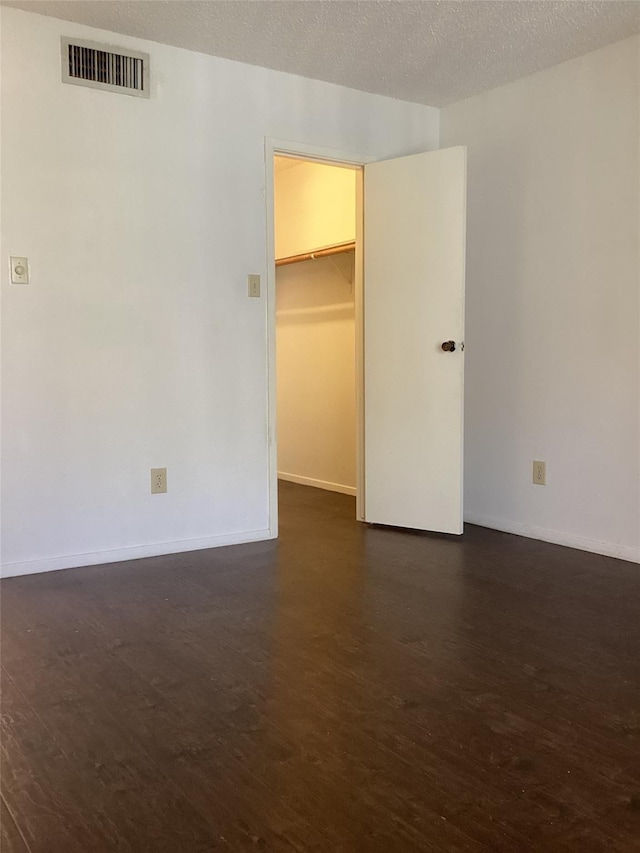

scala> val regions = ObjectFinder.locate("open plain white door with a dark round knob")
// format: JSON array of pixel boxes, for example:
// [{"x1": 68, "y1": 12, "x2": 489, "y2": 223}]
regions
[{"x1": 364, "y1": 148, "x2": 466, "y2": 533}]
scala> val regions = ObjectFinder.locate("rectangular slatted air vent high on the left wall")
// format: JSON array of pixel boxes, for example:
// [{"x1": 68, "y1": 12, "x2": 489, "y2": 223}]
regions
[{"x1": 62, "y1": 38, "x2": 149, "y2": 98}]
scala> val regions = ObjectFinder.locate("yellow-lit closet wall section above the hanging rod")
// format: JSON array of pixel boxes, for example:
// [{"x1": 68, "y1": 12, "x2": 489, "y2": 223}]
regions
[{"x1": 274, "y1": 161, "x2": 356, "y2": 258}]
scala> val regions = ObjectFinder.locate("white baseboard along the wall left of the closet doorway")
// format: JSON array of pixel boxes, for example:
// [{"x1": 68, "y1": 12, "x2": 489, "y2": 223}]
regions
[{"x1": 0, "y1": 530, "x2": 273, "y2": 578}]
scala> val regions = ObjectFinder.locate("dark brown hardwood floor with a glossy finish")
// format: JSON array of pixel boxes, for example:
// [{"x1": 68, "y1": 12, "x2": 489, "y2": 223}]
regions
[{"x1": 0, "y1": 484, "x2": 640, "y2": 853}]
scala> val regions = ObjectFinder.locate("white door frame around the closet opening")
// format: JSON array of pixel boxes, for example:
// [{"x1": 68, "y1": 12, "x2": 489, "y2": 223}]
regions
[{"x1": 264, "y1": 136, "x2": 379, "y2": 539}]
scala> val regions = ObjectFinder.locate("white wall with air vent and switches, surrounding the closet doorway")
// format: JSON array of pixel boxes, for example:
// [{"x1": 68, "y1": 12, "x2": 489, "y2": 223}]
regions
[{"x1": 1, "y1": 8, "x2": 438, "y2": 574}]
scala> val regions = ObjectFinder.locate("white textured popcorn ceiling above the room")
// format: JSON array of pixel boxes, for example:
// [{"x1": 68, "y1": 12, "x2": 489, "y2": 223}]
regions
[{"x1": 1, "y1": 0, "x2": 640, "y2": 106}]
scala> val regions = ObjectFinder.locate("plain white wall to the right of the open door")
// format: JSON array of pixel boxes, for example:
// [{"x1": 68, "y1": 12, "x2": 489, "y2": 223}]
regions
[{"x1": 441, "y1": 37, "x2": 640, "y2": 560}]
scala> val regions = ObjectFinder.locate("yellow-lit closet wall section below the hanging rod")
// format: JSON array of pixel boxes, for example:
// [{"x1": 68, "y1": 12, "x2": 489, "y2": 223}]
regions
[{"x1": 276, "y1": 255, "x2": 356, "y2": 495}]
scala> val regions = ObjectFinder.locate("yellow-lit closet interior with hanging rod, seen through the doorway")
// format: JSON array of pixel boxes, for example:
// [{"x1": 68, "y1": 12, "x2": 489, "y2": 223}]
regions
[{"x1": 274, "y1": 156, "x2": 357, "y2": 495}]
